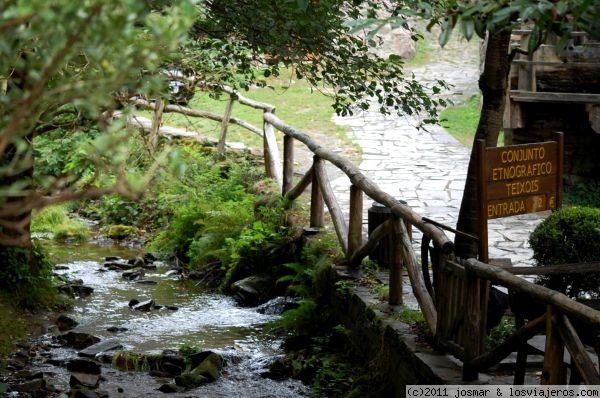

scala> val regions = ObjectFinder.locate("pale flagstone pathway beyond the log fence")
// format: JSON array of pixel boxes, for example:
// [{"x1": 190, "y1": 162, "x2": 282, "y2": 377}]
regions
[{"x1": 332, "y1": 33, "x2": 542, "y2": 265}]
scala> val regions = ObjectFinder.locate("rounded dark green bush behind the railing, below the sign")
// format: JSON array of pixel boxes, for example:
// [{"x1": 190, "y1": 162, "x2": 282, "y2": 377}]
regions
[{"x1": 529, "y1": 207, "x2": 600, "y2": 298}]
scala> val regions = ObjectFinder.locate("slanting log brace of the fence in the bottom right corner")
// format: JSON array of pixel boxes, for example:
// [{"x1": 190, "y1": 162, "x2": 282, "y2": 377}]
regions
[{"x1": 554, "y1": 314, "x2": 600, "y2": 385}]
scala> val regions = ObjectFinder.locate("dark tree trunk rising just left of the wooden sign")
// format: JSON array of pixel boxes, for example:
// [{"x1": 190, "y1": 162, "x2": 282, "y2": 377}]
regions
[{"x1": 454, "y1": 31, "x2": 510, "y2": 258}]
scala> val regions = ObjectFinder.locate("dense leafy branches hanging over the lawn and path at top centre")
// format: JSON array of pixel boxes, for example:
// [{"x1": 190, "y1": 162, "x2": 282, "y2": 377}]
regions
[{"x1": 186, "y1": 0, "x2": 443, "y2": 122}]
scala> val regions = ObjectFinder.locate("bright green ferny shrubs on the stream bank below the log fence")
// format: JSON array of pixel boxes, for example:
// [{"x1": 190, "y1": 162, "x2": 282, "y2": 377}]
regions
[{"x1": 151, "y1": 146, "x2": 261, "y2": 268}]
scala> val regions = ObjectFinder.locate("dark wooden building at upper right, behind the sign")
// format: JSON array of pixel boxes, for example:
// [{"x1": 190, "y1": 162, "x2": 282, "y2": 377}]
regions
[{"x1": 504, "y1": 30, "x2": 600, "y2": 183}]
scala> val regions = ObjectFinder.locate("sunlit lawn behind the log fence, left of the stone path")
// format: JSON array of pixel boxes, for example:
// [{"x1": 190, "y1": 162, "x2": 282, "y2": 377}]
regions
[{"x1": 140, "y1": 70, "x2": 356, "y2": 158}]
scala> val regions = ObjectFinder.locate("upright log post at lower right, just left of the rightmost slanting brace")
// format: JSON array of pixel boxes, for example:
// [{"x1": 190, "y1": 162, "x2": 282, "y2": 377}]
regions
[{"x1": 540, "y1": 305, "x2": 567, "y2": 385}]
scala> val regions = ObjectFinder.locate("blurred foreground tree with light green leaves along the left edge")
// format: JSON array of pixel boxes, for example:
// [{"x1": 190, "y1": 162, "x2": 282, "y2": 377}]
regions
[{"x1": 0, "y1": 0, "x2": 195, "y2": 272}]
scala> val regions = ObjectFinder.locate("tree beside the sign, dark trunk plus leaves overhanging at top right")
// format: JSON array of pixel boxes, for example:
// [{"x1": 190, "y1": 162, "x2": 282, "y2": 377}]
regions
[{"x1": 421, "y1": 0, "x2": 600, "y2": 258}]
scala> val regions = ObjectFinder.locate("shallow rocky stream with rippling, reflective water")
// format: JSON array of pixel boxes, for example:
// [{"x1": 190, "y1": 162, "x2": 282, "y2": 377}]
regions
[{"x1": 0, "y1": 244, "x2": 308, "y2": 397}]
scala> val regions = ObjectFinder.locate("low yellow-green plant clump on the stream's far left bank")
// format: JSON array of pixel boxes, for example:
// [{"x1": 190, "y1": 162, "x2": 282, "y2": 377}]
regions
[{"x1": 31, "y1": 205, "x2": 90, "y2": 241}]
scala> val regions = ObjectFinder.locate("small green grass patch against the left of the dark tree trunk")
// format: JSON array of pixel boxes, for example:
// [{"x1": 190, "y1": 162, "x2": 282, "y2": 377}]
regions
[{"x1": 440, "y1": 95, "x2": 481, "y2": 147}]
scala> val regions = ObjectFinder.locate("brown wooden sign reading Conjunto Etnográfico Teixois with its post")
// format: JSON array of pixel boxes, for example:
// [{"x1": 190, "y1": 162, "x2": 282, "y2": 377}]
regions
[{"x1": 478, "y1": 133, "x2": 563, "y2": 262}]
